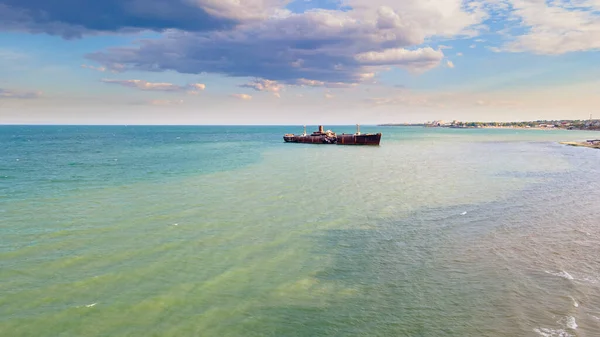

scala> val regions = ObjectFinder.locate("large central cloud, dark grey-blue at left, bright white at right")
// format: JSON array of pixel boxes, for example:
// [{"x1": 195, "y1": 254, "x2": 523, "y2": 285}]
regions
[{"x1": 86, "y1": 0, "x2": 486, "y2": 86}]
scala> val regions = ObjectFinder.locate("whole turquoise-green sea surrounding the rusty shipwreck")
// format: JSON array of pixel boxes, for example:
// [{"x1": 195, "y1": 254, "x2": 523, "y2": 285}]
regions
[{"x1": 0, "y1": 126, "x2": 600, "y2": 337}]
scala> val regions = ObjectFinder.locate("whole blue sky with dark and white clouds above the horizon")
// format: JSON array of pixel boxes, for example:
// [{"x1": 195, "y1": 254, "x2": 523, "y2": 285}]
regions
[{"x1": 0, "y1": 0, "x2": 600, "y2": 125}]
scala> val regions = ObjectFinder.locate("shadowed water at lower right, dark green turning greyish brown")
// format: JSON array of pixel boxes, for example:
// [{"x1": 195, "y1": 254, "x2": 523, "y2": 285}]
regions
[{"x1": 265, "y1": 154, "x2": 600, "y2": 336}]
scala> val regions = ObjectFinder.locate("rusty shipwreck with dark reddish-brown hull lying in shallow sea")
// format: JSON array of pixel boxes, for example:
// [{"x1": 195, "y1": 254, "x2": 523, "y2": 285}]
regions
[{"x1": 283, "y1": 125, "x2": 381, "y2": 145}]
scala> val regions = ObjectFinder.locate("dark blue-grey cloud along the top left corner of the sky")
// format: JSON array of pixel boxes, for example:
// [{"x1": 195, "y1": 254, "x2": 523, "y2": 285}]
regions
[{"x1": 0, "y1": 0, "x2": 284, "y2": 38}]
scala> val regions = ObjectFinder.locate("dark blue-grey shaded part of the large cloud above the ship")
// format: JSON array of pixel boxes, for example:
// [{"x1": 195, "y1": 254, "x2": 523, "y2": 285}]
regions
[{"x1": 88, "y1": 34, "x2": 356, "y2": 81}]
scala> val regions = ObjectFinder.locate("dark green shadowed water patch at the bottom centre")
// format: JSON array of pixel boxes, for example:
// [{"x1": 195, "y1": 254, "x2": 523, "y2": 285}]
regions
[{"x1": 253, "y1": 224, "x2": 509, "y2": 336}]
